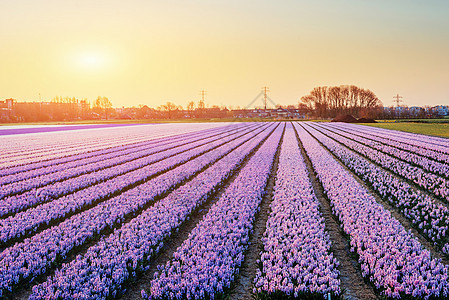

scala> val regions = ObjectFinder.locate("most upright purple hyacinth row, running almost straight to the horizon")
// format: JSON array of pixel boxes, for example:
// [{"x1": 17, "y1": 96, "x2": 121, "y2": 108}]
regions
[{"x1": 254, "y1": 124, "x2": 341, "y2": 298}]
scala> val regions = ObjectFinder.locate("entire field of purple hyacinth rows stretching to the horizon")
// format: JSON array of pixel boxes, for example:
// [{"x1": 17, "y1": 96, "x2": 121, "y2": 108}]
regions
[{"x1": 0, "y1": 122, "x2": 449, "y2": 299}]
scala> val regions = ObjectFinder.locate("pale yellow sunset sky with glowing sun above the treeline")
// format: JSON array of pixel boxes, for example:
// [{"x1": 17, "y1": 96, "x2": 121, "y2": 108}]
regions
[{"x1": 0, "y1": 0, "x2": 449, "y2": 107}]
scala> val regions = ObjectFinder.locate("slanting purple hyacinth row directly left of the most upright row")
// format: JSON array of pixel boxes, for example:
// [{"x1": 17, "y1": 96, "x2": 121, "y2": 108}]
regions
[{"x1": 142, "y1": 126, "x2": 284, "y2": 299}]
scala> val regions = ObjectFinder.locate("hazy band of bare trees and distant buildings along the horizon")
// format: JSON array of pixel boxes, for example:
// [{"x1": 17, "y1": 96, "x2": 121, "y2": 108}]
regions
[{"x1": 0, "y1": 86, "x2": 449, "y2": 123}]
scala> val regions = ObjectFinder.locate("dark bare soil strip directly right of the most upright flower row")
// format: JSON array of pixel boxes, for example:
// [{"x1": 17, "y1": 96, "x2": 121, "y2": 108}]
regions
[{"x1": 295, "y1": 122, "x2": 378, "y2": 300}]
